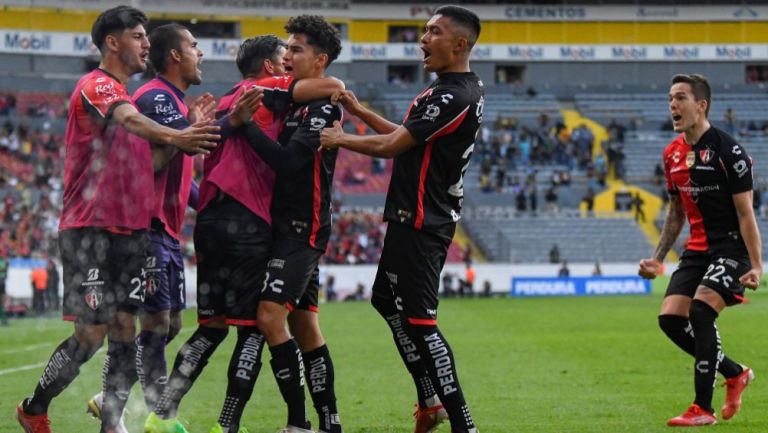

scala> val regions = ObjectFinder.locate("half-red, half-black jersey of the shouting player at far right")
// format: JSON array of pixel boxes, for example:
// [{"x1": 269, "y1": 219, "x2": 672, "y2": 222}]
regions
[{"x1": 664, "y1": 127, "x2": 752, "y2": 251}]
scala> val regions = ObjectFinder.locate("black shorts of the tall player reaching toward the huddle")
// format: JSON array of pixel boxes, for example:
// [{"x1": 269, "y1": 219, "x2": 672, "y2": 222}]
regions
[{"x1": 373, "y1": 223, "x2": 451, "y2": 325}]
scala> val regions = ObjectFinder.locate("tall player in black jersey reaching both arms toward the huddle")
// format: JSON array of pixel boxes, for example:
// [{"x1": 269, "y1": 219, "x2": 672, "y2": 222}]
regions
[{"x1": 321, "y1": 6, "x2": 484, "y2": 433}]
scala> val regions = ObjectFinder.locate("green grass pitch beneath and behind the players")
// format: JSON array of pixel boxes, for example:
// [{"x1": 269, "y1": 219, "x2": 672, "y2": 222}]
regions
[{"x1": 0, "y1": 280, "x2": 768, "y2": 433}]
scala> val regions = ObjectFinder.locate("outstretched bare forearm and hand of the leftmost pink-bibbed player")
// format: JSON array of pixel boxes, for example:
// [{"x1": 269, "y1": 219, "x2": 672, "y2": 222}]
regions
[{"x1": 112, "y1": 104, "x2": 220, "y2": 154}]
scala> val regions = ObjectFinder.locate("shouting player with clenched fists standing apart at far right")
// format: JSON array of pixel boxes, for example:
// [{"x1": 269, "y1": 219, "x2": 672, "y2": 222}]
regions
[{"x1": 639, "y1": 74, "x2": 762, "y2": 426}]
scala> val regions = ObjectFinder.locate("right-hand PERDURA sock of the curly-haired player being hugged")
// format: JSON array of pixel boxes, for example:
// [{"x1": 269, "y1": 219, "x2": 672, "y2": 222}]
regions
[{"x1": 303, "y1": 345, "x2": 343, "y2": 433}]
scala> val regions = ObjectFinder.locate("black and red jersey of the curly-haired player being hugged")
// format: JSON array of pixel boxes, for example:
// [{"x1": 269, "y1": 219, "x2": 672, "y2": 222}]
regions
[{"x1": 272, "y1": 99, "x2": 341, "y2": 251}]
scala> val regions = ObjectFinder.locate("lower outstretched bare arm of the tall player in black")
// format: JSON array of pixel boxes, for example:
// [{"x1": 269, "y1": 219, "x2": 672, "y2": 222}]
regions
[{"x1": 320, "y1": 122, "x2": 416, "y2": 158}]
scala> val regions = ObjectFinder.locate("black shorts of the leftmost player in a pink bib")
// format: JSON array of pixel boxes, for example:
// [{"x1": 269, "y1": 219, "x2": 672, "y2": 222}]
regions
[{"x1": 59, "y1": 227, "x2": 149, "y2": 325}]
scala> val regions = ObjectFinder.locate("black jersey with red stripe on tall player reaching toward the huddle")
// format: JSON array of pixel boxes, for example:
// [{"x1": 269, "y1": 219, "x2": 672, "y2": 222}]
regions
[{"x1": 384, "y1": 72, "x2": 484, "y2": 239}]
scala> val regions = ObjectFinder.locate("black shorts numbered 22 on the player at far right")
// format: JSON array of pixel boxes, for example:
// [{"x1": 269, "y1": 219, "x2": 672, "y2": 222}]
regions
[{"x1": 665, "y1": 250, "x2": 750, "y2": 305}]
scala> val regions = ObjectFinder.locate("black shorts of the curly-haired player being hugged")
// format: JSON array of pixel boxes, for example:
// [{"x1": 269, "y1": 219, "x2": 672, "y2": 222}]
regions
[{"x1": 261, "y1": 239, "x2": 323, "y2": 310}]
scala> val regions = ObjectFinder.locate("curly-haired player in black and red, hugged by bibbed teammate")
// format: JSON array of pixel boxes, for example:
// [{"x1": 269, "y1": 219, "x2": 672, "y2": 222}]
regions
[{"x1": 240, "y1": 15, "x2": 342, "y2": 433}]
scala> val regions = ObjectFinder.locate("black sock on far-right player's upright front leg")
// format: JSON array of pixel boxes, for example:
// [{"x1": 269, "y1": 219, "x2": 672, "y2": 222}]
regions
[{"x1": 690, "y1": 299, "x2": 721, "y2": 412}]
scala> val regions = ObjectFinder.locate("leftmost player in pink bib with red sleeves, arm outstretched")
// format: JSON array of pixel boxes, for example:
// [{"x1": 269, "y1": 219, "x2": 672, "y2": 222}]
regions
[{"x1": 16, "y1": 6, "x2": 219, "y2": 433}]
